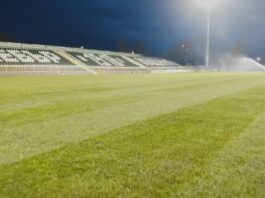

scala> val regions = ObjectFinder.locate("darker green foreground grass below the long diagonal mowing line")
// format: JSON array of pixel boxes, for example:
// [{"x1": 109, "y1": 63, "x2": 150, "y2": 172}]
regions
[{"x1": 0, "y1": 73, "x2": 265, "y2": 197}]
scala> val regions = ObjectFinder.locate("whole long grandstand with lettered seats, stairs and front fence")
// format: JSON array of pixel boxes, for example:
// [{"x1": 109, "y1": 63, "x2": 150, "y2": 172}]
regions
[{"x1": 0, "y1": 42, "x2": 188, "y2": 75}]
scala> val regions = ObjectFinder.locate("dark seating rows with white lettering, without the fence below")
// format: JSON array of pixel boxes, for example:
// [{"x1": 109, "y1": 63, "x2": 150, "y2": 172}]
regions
[{"x1": 0, "y1": 46, "x2": 179, "y2": 68}]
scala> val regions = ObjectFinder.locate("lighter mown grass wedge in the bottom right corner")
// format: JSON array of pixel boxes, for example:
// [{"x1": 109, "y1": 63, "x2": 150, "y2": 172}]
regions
[{"x1": 174, "y1": 114, "x2": 265, "y2": 197}]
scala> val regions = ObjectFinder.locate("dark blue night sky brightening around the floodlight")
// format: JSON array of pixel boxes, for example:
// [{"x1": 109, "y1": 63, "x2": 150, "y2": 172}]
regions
[{"x1": 0, "y1": 0, "x2": 265, "y2": 62}]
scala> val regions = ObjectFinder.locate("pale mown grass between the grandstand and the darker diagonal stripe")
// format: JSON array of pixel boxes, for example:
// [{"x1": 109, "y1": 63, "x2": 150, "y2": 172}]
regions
[{"x1": 0, "y1": 73, "x2": 265, "y2": 164}]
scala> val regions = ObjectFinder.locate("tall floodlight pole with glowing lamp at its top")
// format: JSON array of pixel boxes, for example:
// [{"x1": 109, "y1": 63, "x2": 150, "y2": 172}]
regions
[{"x1": 194, "y1": 0, "x2": 217, "y2": 68}]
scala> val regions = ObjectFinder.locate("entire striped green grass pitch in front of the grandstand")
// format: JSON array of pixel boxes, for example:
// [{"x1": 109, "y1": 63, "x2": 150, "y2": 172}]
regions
[{"x1": 0, "y1": 73, "x2": 265, "y2": 197}]
